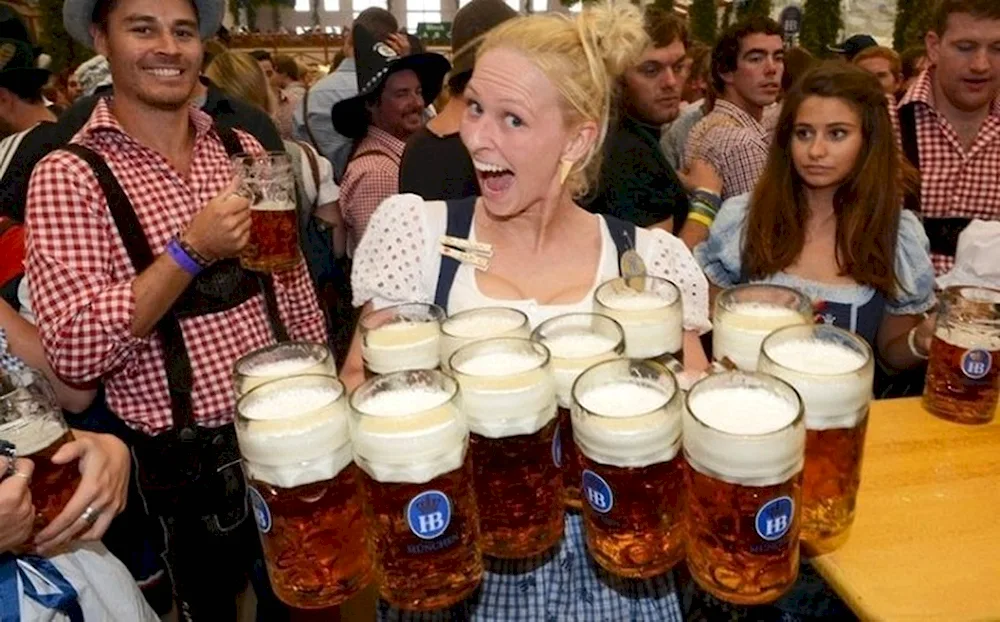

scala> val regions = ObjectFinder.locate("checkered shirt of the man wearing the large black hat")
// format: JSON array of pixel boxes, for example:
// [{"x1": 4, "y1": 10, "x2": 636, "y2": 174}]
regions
[{"x1": 340, "y1": 125, "x2": 406, "y2": 254}]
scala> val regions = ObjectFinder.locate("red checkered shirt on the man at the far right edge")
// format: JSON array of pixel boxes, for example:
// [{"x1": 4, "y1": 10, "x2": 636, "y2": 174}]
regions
[{"x1": 899, "y1": 69, "x2": 1000, "y2": 274}]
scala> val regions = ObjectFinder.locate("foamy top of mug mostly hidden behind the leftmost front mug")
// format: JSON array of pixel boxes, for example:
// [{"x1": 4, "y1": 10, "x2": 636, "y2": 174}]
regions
[{"x1": 233, "y1": 341, "x2": 337, "y2": 397}]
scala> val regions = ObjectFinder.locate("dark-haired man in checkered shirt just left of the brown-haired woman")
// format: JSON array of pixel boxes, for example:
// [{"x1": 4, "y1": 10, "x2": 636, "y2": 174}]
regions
[{"x1": 684, "y1": 17, "x2": 785, "y2": 199}]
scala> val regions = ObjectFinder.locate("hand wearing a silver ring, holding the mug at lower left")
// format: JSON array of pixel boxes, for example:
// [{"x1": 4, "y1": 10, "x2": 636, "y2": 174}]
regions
[{"x1": 35, "y1": 430, "x2": 132, "y2": 553}]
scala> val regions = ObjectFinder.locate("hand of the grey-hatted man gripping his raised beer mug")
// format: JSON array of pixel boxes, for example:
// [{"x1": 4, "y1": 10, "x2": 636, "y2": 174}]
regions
[{"x1": 184, "y1": 179, "x2": 250, "y2": 261}]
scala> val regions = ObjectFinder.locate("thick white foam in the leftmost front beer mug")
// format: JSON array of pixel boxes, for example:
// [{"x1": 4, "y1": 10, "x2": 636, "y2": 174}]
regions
[{"x1": 236, "y1": 386, "x2": 352, "y2": 488}]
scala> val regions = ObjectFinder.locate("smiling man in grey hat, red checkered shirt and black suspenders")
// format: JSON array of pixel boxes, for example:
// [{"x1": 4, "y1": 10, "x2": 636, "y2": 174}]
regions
[{"x1": 26, "y1": 0, "x2": 326, "y2": 620}]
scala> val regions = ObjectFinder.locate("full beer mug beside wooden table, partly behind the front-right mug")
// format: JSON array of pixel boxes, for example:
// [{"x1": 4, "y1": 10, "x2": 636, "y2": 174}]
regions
[{"x1": 758, "y1": 324, "x2": 875, "y2": 555}]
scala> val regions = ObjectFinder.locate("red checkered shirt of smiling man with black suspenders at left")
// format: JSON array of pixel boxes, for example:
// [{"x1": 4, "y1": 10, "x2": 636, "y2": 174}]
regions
[{"x1": 27, "y1": 101, "x2": 326, "y2": 434}]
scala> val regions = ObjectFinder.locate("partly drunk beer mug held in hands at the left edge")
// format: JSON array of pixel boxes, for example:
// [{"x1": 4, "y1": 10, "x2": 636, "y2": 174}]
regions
[{"x1": 0, "y1": 370, "x2": 80, "y2": 536}]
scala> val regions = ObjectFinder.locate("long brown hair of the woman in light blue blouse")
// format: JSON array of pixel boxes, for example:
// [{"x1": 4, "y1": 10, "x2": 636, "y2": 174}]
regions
[{"x1": 742, "y1": 62, "x2": 917, "y2": 299}]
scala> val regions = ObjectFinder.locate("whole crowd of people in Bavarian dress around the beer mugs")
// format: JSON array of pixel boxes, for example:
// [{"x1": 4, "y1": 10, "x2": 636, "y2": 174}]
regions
[{"x1": 0, "y1": 0, "x2": 1000, "y2": 621}]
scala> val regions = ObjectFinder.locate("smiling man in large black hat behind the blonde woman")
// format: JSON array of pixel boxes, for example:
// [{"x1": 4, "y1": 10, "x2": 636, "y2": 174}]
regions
[{"x1": 333, "y1": 24, "x2": 451, "y2": 255}]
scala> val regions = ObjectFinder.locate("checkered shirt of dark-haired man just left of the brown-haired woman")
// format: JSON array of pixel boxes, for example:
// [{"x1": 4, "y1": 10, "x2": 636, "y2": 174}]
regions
[{"x1": 684, "y1": 99, "x2": 780, "y2": 199}]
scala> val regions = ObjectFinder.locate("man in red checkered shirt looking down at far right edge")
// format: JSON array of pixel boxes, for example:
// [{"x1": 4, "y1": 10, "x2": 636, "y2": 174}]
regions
[{"x1": 899, "y1": 0, "x2": 1000, "y2": 274}]
